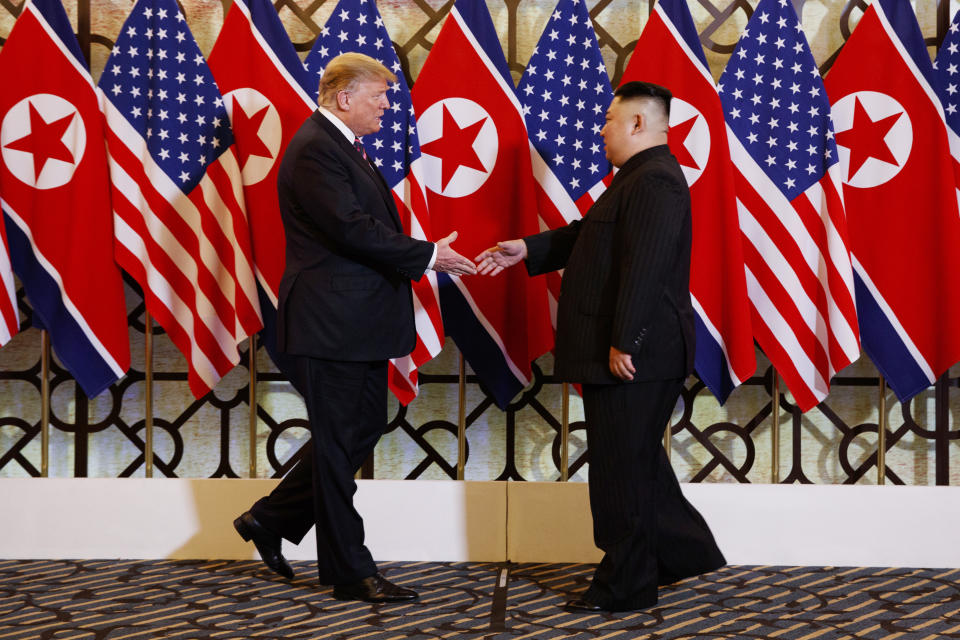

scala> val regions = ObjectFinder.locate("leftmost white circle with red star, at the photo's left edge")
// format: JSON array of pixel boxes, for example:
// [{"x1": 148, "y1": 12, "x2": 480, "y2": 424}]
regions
[{"x1": 0, "y1": 93, "x2": 87, "y2": 189}]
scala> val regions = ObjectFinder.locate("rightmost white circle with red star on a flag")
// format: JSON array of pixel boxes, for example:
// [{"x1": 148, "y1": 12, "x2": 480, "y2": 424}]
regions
[{"x1": 830, "y1": 91, "x2": 913, "y2": 189}]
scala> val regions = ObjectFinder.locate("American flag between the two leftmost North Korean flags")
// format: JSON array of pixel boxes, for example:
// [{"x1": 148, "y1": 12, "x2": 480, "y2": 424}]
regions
[{"x1": 98, "y1": 0, "x2": 262, "y2": 397}]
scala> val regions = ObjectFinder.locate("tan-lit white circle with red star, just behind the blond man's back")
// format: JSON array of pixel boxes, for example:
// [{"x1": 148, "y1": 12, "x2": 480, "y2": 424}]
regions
[{"x1": 223, "y1": 87, "x2": 283, "y2": 186}]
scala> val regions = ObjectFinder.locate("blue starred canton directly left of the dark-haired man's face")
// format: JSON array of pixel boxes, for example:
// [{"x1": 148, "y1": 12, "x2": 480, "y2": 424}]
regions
[{"x1": 517, "y1": 0, "x2": 613, "y2": 201}]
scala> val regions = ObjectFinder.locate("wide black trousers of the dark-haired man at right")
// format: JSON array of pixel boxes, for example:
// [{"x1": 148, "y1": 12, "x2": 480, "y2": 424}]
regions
[{"x1": 583, "y1": 380, "x2": 726, "y2": 611}]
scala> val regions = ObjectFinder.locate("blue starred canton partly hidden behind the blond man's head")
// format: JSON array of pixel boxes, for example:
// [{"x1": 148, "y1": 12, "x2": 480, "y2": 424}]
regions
[{"x1": 306, "y1": 0, "x2": 420, "y2": 188}]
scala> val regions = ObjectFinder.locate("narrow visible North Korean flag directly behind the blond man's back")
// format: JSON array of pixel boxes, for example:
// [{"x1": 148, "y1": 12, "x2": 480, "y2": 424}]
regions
[{"x1": 209, "y1": 0, "x2": 316, "y2": 378}]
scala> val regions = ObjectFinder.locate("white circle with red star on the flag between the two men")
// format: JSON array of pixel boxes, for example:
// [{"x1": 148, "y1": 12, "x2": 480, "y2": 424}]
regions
[{"x1": 417, "y1": 98, "x2": 499, "y2": 198}]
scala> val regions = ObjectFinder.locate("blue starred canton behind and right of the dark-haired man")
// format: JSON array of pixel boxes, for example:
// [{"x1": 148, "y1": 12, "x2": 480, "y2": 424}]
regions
[{"x1": 717, "y1": 0, "x2": 837, "y2": 201}]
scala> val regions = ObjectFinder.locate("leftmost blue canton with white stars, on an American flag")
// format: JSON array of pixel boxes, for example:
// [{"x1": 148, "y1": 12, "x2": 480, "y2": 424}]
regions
[{"x1": 98, "y1": 0, "x2": 233, "y2": 193}]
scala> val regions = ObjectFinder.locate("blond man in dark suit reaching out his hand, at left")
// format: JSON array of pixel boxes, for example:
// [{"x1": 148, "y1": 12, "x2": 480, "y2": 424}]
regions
[{"x1": 234, "y1": 53, "x2": 475, "y2": 602}]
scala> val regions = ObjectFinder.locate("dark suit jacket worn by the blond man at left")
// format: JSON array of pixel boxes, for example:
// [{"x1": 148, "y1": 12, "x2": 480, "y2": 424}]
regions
[{"x1": 277, "y1": 112, "x2": 433, "y2": 361}]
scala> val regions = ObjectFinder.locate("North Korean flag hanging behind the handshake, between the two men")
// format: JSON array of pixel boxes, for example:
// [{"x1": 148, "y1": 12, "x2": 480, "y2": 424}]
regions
[{"x1": 413, "y1": 0, "x2": 552, "y2": 408}]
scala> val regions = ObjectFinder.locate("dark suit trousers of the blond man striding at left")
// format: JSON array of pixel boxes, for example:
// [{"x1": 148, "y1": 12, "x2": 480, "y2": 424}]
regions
[{"x1": 250, "y1": 356, "x2": 387, "y2": 584}]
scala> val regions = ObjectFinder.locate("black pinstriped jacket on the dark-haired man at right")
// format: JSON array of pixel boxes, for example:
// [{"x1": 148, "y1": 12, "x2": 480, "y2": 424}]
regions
[{"x1": 525, "y1": 145, "x2": 696, "y2": 384}]
